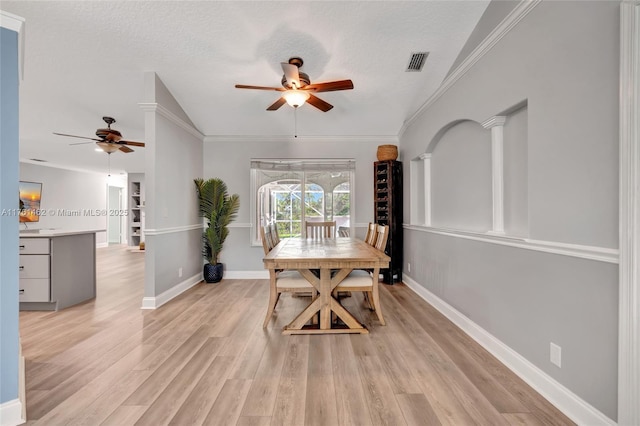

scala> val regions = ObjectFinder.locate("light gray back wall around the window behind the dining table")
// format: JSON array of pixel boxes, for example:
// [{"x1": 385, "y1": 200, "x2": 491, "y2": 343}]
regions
[{"x1": 204, "y1": 138, "x2": 393, "y2": 272}]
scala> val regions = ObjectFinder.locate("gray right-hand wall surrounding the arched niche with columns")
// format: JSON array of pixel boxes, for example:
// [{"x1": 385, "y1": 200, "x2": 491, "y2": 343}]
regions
[{"x1": 400, "y1": 1, "x2": 619, "y2": 419}]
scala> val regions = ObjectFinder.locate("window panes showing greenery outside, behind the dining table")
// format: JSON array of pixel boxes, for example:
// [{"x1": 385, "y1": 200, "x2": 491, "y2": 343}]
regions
[{"x1": 257, "y1": 172, "x2": 351, "y2": 238}]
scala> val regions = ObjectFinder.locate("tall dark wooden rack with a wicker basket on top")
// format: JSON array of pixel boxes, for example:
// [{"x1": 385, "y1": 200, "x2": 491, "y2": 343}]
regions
[{"x1": 373, "y1": 160, "x2": 402, "y2": 284}]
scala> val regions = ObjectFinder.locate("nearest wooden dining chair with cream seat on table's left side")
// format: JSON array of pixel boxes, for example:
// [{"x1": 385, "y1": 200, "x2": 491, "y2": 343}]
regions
[{"x1": 260, "y1": 225, "x2": 318, "y2": 328}]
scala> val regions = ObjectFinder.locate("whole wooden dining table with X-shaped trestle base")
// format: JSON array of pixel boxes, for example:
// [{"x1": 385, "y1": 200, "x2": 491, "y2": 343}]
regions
[{"x1": 263, "y1": 237, "x2": 391, "y2": 334}]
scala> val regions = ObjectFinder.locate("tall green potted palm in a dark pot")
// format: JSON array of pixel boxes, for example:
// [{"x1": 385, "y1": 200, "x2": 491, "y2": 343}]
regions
[{"x1": 194, "y1": 178, "x2": 240, "y2": 283}]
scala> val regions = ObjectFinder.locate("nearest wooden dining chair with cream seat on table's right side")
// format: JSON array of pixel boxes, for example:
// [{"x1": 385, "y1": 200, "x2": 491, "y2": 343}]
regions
[{"x1": 333, "y1": 225, "x2": 389, "y2": 325}]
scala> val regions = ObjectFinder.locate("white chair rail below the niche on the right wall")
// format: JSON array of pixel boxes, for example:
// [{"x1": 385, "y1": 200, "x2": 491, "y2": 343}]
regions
[{"x1": 404, "y1": 225, "x2": 619, "y2": 263}]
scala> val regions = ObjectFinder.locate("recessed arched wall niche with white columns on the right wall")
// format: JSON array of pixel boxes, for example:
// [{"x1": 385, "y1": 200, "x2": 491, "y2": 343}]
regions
[{"x1": 410, "y1": 101, "x2": 529, "y2": 237}]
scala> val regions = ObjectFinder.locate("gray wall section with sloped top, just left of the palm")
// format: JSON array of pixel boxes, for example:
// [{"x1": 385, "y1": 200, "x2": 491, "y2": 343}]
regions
[{"x1": 144, "y1": 72, "x2": 203, "y2": 297}]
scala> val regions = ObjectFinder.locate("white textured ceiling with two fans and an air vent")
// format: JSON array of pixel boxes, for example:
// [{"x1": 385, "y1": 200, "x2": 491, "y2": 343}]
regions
[{"x1": 0, "y1": 0, "x2": 488, "y2": 172}]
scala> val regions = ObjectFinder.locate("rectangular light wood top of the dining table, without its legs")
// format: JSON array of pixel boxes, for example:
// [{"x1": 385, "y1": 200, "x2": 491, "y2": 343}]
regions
[{"x1": 263, "y1": 237, "x2": 391, "y2": 269}]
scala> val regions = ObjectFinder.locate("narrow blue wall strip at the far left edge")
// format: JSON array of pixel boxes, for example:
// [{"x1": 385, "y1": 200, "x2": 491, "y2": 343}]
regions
[{"x1": 0, "y1": 24, "x2": 19, "y2": 410}]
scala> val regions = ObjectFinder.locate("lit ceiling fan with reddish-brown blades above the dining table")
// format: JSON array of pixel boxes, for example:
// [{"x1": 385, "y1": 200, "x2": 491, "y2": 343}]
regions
[{"x1": 236, "y1": 57, "x2": 353, "y2": 112}]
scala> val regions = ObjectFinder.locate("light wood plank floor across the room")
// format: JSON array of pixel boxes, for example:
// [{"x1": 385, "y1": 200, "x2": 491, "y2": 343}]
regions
[{"x1": 20, "y1": 246, "x2": 573, "y2": 426}]
